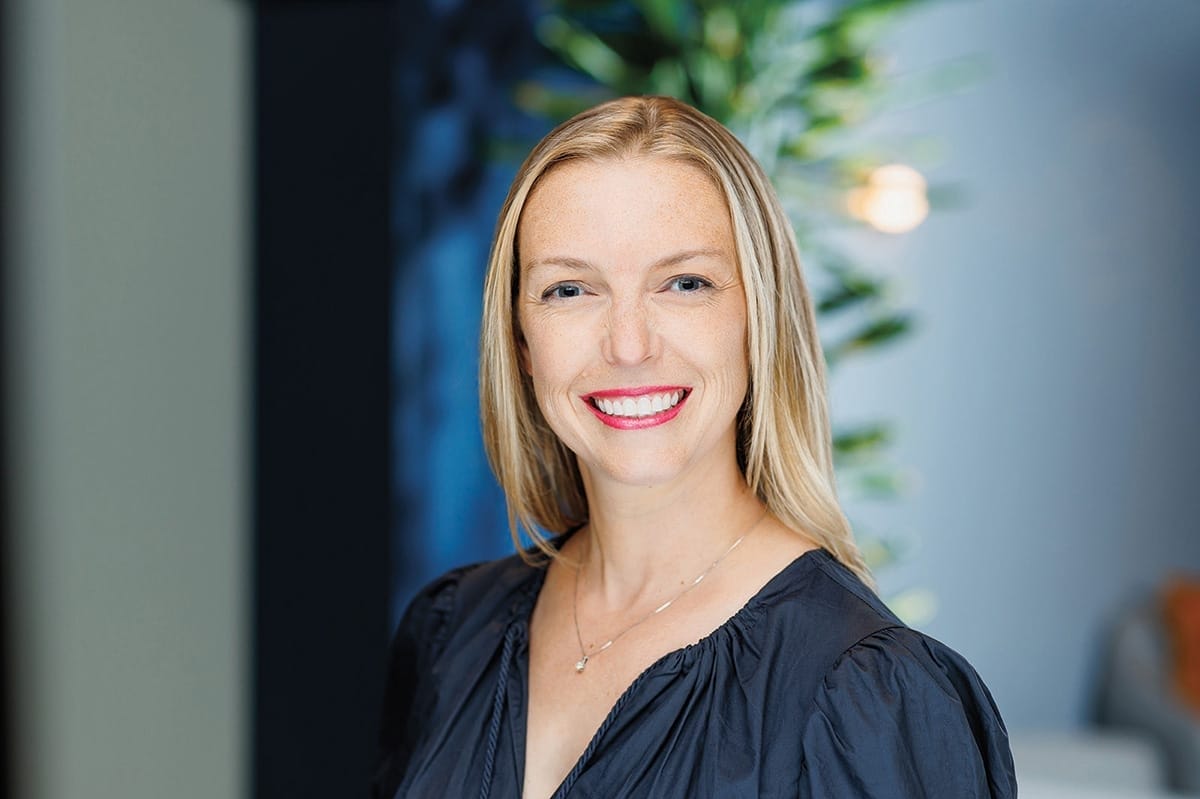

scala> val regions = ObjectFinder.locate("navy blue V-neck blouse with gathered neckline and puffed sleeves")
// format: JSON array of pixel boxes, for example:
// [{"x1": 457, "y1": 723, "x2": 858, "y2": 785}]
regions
[{"x1": 372, "y1": 549, "x2": 1016, "y2": 799}]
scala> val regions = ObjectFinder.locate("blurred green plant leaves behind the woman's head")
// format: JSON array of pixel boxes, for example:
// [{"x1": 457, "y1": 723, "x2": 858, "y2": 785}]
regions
[{"x1": 517, "y1": 0, "x2": 954, "y2": 605}]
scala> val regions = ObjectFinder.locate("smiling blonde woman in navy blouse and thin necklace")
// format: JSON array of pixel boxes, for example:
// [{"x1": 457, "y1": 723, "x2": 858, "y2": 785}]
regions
[{"x1": 374, "y1": 97, "x2": 1015, "y2": 799}]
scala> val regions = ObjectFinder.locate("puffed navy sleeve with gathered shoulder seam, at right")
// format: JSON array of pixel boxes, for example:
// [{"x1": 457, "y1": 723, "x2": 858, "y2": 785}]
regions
[{"x1": 800, "y1": 627, "x2": 1016, "y2": 799}]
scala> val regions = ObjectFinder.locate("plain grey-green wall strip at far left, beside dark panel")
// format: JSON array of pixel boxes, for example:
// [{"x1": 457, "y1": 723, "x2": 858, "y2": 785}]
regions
[{"x1": 4, "y1": 0, "x2": 248, "y2": 799}]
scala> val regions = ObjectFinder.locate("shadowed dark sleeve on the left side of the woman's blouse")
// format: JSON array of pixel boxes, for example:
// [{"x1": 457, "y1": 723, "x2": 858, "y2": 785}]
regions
[{"x1": 371, "y1": 567, "x2": 469, "y2": 799}]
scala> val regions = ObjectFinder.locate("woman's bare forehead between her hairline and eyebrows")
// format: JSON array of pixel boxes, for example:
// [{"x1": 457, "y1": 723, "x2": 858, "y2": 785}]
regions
[{"x1": 517, "y1": 157, "x2": 733, "y2": 264}]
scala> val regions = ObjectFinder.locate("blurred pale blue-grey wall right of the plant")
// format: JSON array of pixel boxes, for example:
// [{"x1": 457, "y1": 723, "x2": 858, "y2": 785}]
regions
[{"x1": 834, "y1": 0, "x2": 1200, "y2": 729}]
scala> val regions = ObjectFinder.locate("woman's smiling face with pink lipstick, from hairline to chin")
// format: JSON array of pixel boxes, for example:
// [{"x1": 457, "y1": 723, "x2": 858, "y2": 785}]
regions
[{"x1": 517, "y1": 157, "x2": 749, "y2": 486}]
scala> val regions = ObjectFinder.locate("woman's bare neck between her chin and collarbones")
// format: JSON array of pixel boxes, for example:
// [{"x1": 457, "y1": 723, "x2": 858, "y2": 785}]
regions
[{"x1": 575, "y1": 464, "x2": 763, "y2": 608}]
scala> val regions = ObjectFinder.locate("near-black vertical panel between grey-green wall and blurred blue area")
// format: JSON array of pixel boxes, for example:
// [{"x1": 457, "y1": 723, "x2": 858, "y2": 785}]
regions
[{"x1": 253, "y1": 0, "x2": 392, "y2": 799}]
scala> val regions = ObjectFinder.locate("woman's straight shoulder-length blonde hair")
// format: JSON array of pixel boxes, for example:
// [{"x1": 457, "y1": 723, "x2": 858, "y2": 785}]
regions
[{"x1": 479, "y1": 97, "x2": 871, "y2": 584}]
